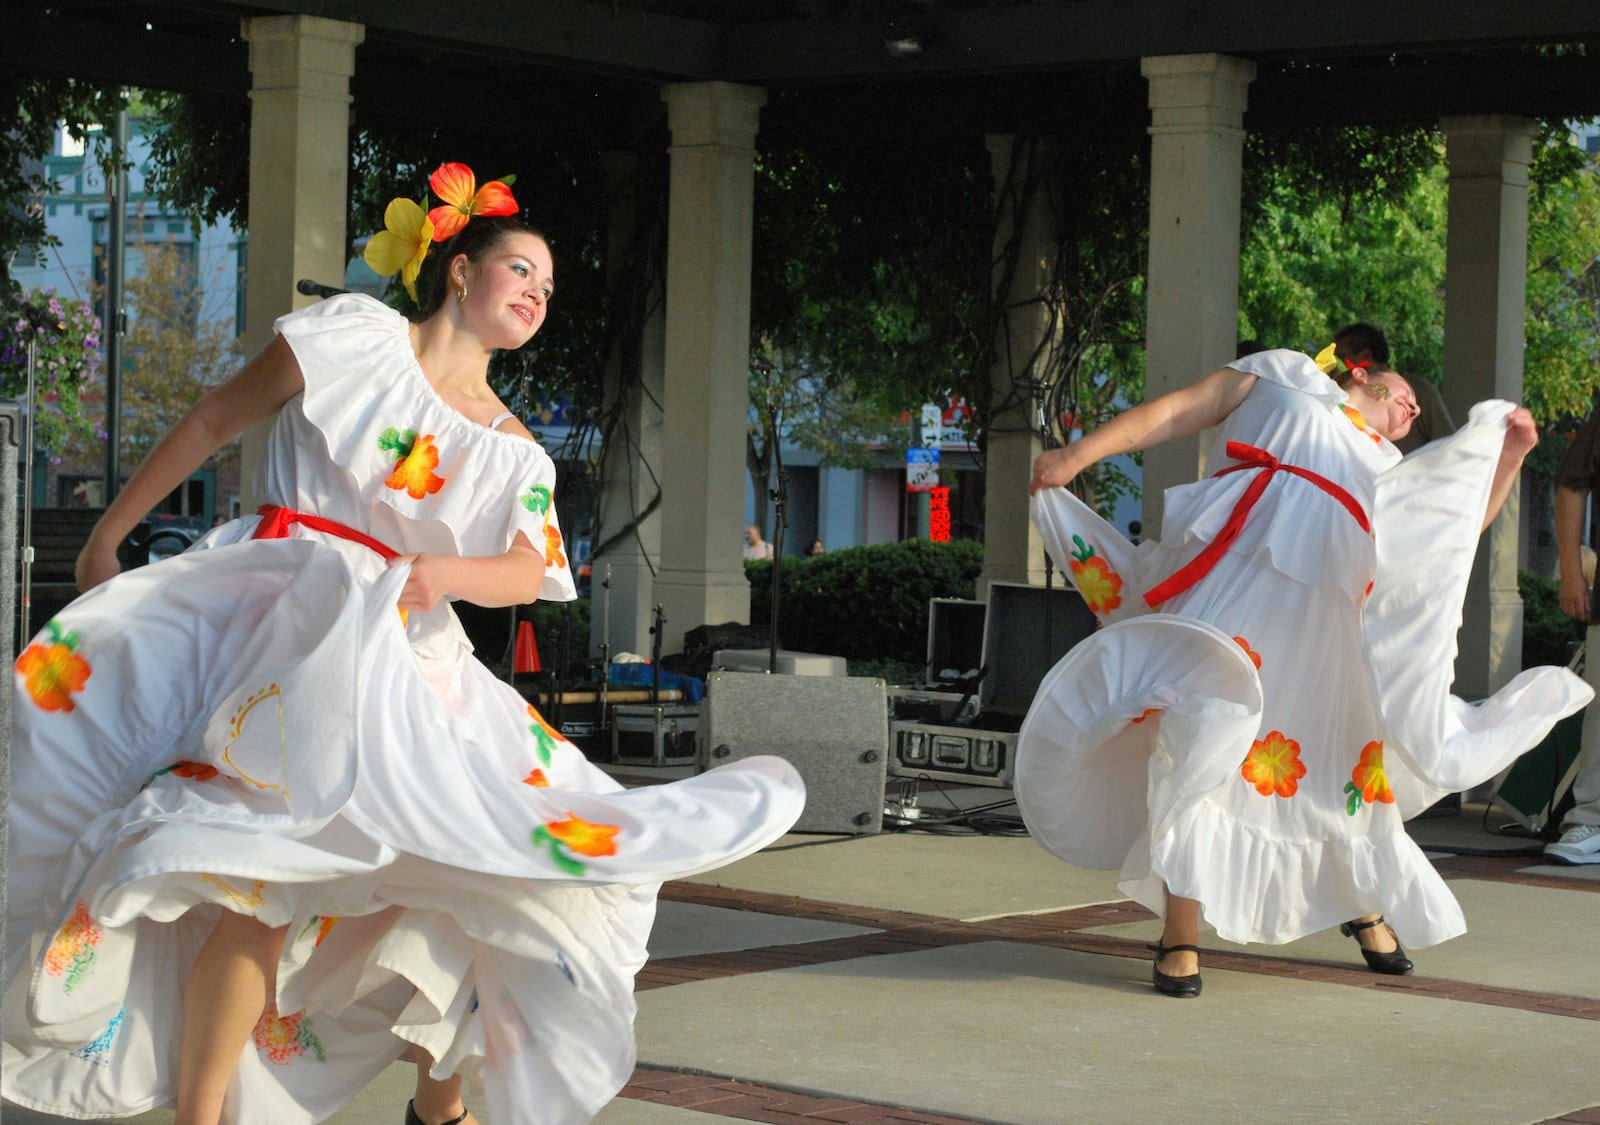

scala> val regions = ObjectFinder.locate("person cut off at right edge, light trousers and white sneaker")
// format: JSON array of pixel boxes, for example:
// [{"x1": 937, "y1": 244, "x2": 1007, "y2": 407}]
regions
[{"x1": 1544, "y1": 410, "x2": 1600, "y2": 864}]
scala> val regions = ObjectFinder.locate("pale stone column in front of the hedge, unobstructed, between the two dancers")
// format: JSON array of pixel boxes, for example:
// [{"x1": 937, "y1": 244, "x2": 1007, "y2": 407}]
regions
[{"x1": 654, "y1": 82, "x2": 766, "y2": 653}]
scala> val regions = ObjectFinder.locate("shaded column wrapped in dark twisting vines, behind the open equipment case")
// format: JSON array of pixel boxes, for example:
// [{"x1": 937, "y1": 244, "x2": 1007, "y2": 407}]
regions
[{"x1": 974, "y1": 133, "x2": 1058, "y2": 600}]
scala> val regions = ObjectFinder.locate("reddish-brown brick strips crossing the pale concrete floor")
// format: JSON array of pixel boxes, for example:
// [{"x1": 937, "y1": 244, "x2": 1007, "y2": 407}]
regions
[{"x1": 619, "y1": 856, "x2": 1600, "y2": 1125}]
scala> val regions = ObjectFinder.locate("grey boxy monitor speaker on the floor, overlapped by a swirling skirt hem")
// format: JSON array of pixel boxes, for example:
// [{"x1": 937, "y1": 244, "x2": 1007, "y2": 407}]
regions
[{"x1": 699, "y1": 672, "x2": 890, "y2": 835}]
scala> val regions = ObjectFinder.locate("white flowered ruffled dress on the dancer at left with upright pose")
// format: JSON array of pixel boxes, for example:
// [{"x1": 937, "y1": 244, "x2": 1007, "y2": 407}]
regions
[{"x1": 0, "y1": 296, "x2": 805, "y2": 1125}]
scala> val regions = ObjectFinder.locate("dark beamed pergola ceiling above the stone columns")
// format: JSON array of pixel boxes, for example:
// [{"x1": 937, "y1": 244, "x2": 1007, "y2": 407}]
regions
[{"x1": 9, "y1": 0, "x2": 1600, "y2": 147}]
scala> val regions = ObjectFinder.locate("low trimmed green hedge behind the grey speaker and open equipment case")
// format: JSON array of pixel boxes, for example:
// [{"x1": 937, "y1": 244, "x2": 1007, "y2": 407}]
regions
[{"x1": 744, "y1": 539, "x2": 984, "y2": 666}]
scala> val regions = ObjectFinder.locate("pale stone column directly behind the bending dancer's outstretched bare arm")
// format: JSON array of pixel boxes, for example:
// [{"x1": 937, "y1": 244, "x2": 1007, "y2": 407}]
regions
[{"x1": 1141, "y1": 54, "x2": 1256, "y2": 536}]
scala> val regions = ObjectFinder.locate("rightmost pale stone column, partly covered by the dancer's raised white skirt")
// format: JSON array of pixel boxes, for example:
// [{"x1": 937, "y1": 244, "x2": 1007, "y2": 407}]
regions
[{"x1": 1440, "y1": 117, "x2": 1536, "y2": 698}]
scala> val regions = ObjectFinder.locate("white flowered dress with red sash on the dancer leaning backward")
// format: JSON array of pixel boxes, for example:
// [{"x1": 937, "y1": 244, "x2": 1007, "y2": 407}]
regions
[{"x1": 1016, "y1": 350, "x2": 1592, "y2": 946}]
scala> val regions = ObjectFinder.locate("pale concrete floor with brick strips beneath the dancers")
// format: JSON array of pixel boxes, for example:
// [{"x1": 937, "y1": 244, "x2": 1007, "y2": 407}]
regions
[{"x1": 3, "y1": 791, "x2": 1600, "y2": 1125}]
